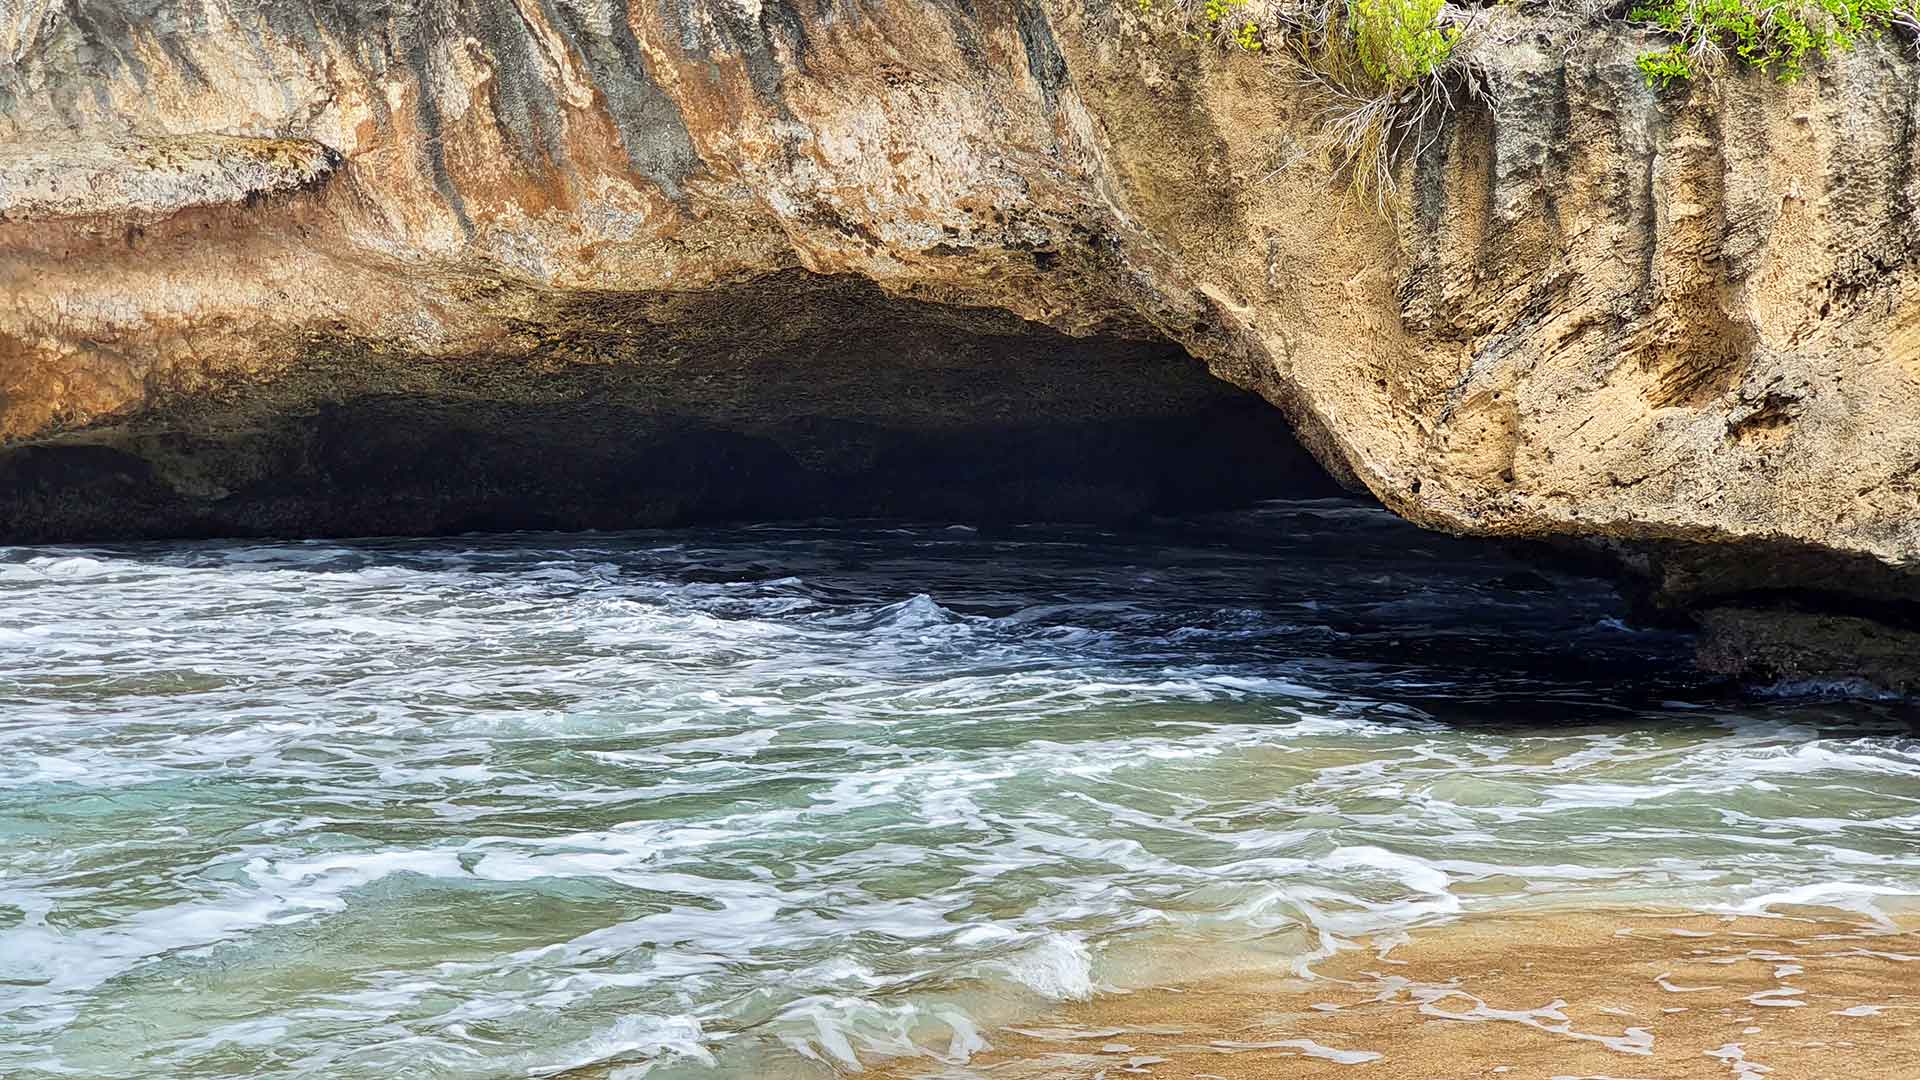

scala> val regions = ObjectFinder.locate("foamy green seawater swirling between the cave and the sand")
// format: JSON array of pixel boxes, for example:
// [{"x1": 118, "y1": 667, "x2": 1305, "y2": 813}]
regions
[{"x1": 0, "y1": 502, "x2": 1920, "y2": 1078}]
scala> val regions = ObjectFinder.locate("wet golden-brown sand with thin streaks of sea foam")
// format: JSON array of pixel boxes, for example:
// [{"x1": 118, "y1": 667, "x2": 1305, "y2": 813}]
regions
[{"x1": 890, "y1": 913, "x2": 1920, "y2": 1080}]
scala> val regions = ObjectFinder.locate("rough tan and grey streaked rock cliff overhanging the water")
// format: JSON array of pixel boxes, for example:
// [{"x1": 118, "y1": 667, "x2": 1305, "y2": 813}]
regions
[{"x1": 0, "y1": 0, "x2": 1920, "y2": 680}]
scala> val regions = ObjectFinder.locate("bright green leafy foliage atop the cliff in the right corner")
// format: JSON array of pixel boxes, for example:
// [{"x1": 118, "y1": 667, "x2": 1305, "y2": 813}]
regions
[{"x1": 1628, "y1": 0, "x2": 1914, "y2": 88}]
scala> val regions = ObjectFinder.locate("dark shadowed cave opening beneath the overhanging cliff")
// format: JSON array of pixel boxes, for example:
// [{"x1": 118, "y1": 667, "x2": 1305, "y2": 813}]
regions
[{"x1": 0, "y1": 271, "x2": 1338, "y2": 544}]
